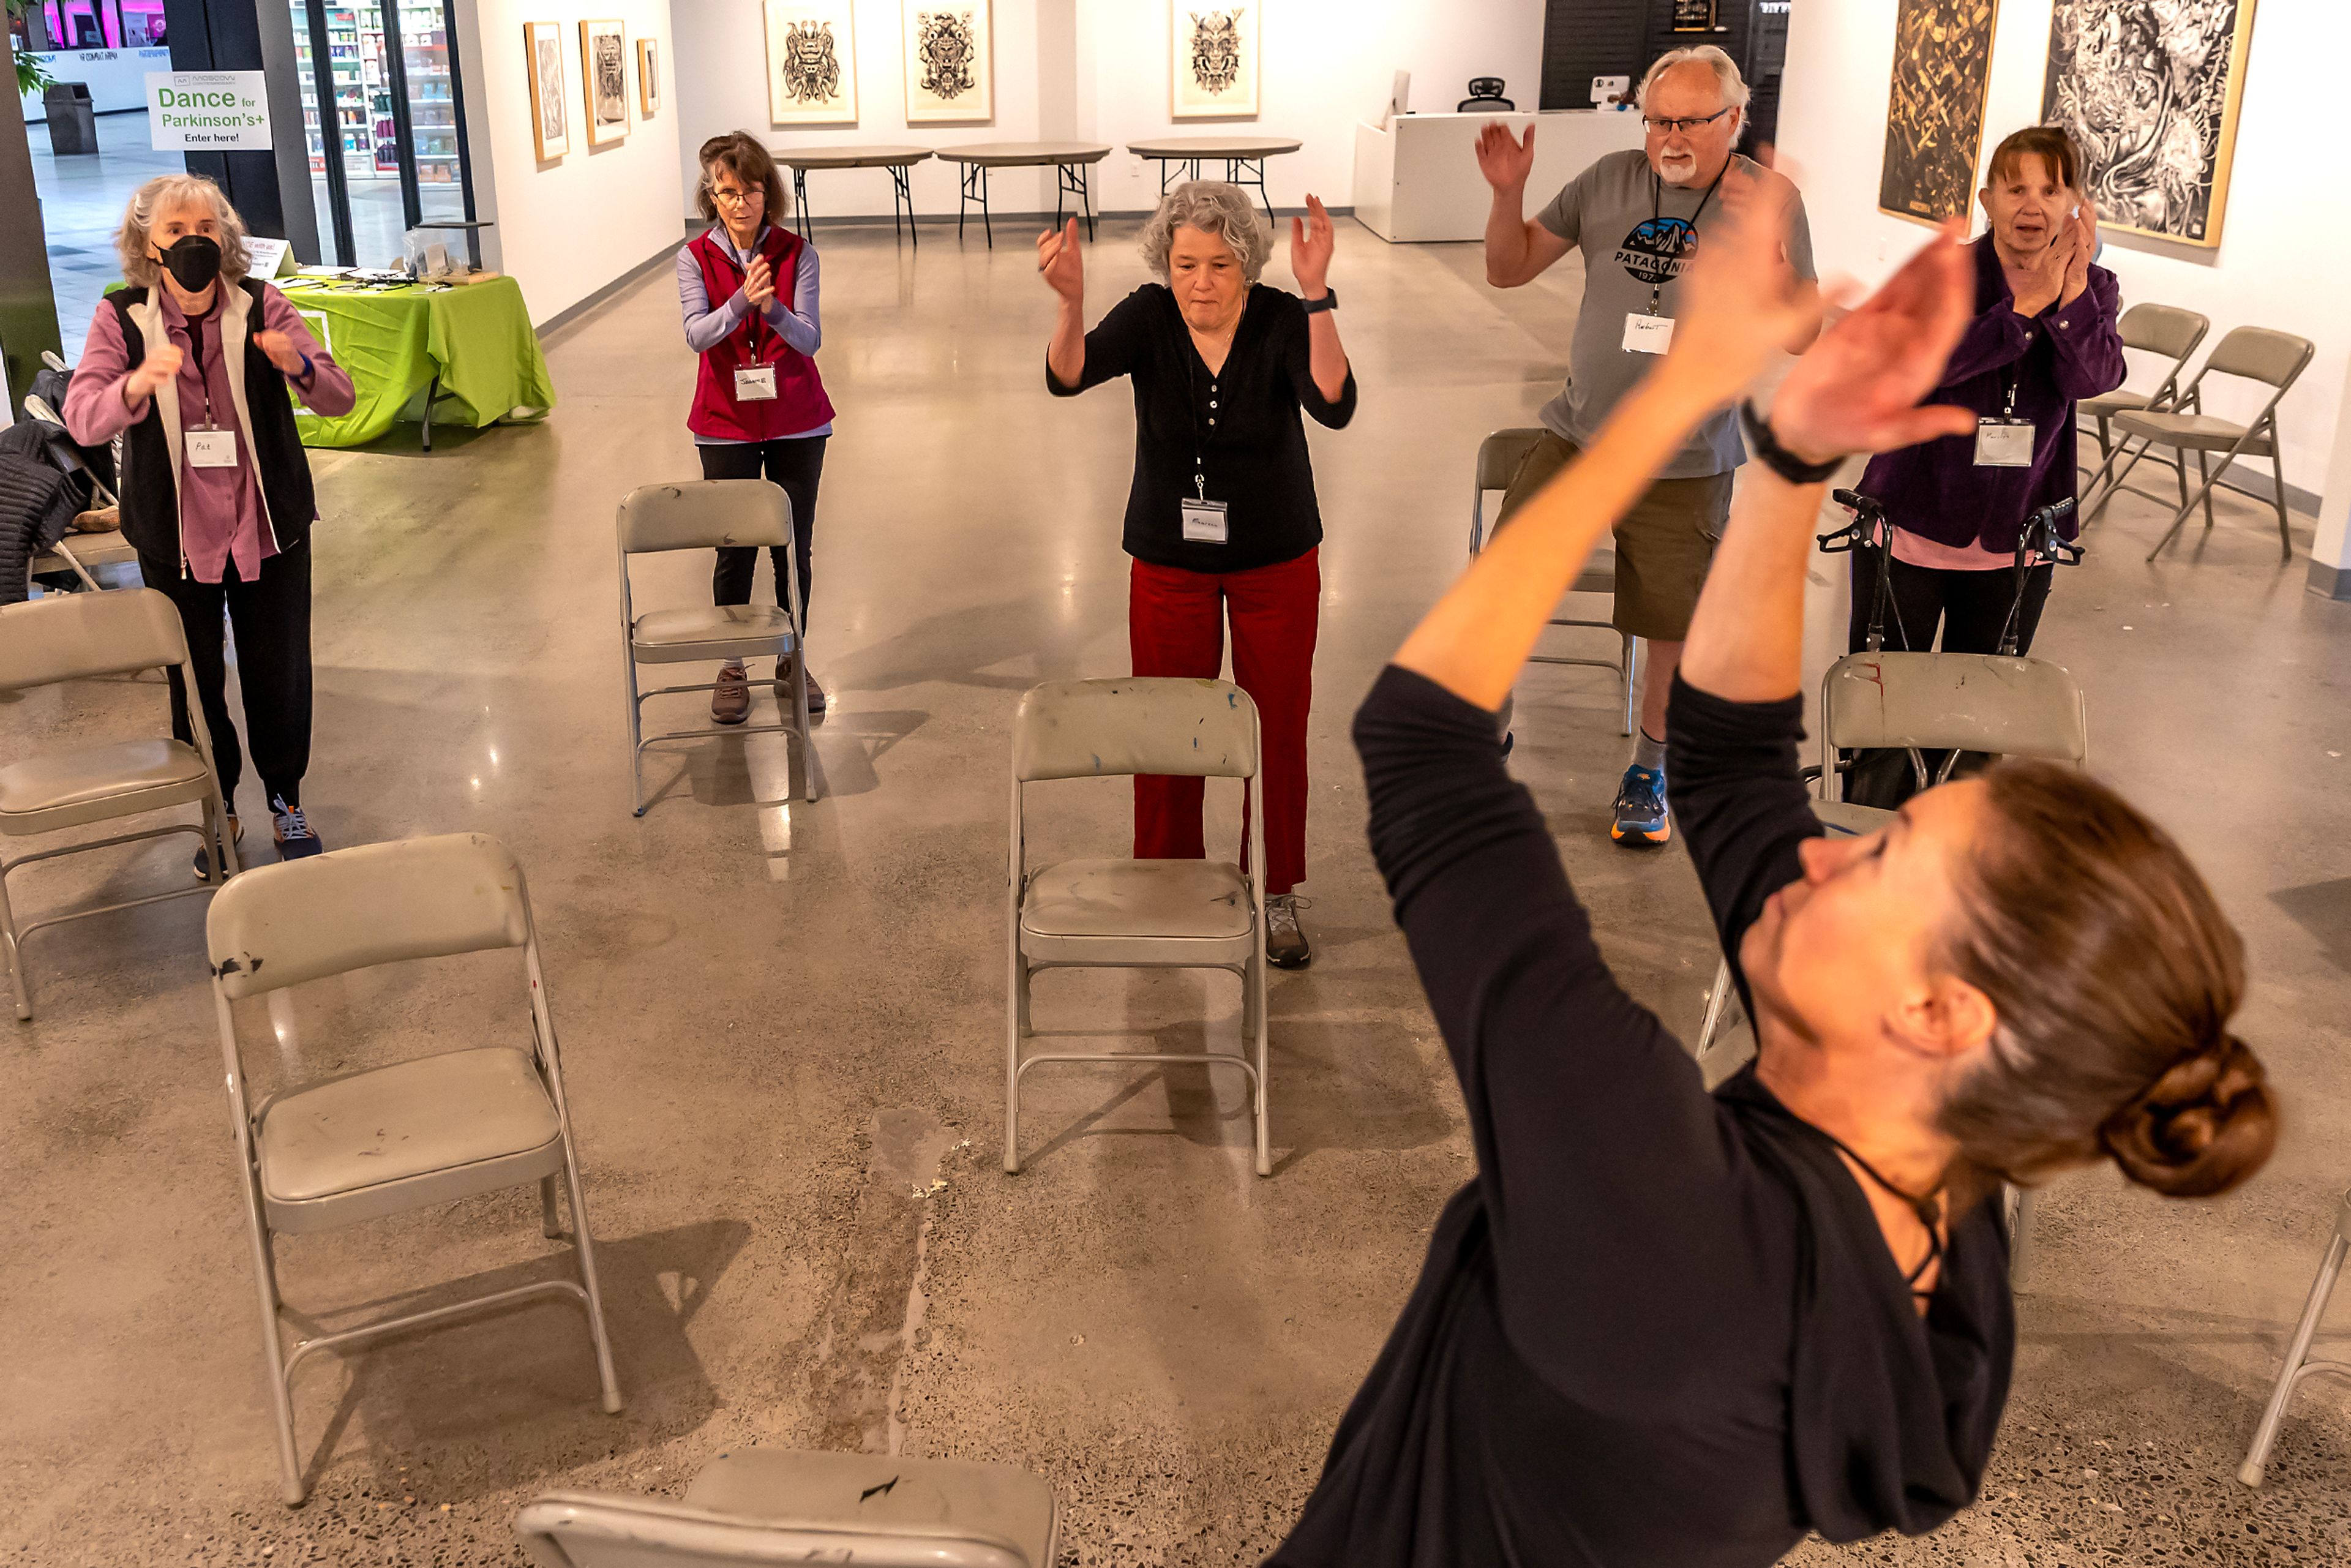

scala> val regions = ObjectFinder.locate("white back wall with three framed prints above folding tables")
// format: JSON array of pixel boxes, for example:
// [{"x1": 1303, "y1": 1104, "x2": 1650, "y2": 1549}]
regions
[{"x1": 670, "y1": 0, "x2": 1542, "y2": 216}]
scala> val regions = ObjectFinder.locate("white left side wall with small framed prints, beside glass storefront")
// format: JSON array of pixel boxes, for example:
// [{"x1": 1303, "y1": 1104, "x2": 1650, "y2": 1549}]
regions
[{"x1": 459, "y1": 0, "x2": 680, "y2": 324}]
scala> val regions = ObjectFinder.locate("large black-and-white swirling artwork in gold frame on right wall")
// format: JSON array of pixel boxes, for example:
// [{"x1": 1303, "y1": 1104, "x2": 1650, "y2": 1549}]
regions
[{"x1": 2041, "y1": 0, "x2": 2255, "y2": 247}]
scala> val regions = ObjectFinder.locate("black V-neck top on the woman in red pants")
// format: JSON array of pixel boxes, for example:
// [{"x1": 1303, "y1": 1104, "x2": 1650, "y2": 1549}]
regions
[{"x1": 1044, "y1": 282, "x2": 1354, "y2": 571}]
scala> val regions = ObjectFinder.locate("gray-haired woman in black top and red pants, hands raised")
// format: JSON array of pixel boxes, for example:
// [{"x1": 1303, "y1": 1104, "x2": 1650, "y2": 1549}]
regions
[{"x1": 1037, "y1": 181, "x2": 1354, "y2": 969}]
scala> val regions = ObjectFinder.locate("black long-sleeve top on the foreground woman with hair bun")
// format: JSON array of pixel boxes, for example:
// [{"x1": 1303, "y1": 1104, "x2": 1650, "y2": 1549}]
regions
[{"x1": 1270, "y1": 667, "x2": 2015, "y2": 1568}]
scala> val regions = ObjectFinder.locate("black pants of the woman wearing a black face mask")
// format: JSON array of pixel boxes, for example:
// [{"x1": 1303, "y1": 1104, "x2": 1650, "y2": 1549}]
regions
[{"x1": 139, "y1": 541, "x2": 310, "y2": 811}]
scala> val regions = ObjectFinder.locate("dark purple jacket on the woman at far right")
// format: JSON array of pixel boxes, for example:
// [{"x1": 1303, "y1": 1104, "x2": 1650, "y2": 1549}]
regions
[{"x1": 1862, "y1": 235, "x2": 2130, "y2": 555}]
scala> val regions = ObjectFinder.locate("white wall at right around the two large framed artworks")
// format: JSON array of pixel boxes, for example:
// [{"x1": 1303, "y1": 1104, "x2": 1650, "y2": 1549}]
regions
[{"x1": 1780, "y1": 0, "x2": 2351, "y2": 493}]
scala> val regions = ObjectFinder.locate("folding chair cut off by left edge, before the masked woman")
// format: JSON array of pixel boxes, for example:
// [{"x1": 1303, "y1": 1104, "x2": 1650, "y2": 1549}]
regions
[{"x1": 0, "y1": 588, "x2": 238, "y2": 1018}]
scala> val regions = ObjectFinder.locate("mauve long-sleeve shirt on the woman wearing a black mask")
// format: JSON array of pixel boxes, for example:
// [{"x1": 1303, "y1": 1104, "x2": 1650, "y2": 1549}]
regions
[{"x1": 61, "y1": 285, "x2": 358, "y2": 583}]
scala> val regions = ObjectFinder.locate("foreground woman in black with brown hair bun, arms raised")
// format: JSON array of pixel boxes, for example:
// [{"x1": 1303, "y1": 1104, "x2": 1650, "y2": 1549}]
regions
[{"x1": 1270, "y1": 190, "x2": 2273, "y2": 1568}]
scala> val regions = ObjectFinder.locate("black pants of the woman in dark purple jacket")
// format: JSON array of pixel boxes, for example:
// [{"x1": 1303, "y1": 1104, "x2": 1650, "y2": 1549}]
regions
[{"x1": 1845, "y1": 548, "x2": 2057, "y2": 811}]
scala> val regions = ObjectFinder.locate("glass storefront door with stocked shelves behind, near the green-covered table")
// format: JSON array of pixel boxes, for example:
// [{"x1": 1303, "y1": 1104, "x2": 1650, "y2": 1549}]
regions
[{"x1": 289, "y1": 0, "x2": 473, "y2": 268}]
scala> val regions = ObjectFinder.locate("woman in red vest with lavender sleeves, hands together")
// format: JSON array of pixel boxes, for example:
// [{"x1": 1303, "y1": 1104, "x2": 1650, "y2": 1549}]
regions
[{"x1": 677, "y1": 132, "x2": 832, "y2": 724}]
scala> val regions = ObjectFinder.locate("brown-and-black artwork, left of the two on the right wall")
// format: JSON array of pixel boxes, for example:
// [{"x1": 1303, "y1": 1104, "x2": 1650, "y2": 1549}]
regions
[{"x1": 1878, "y1": 0, "x2": 1998, "y2": 223}]
